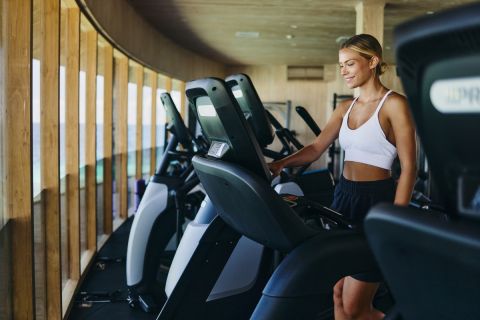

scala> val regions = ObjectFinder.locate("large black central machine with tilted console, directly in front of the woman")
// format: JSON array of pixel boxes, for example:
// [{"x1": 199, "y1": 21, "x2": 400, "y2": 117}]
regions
[{"x1": 187, "y1": 78, "x2": 375, "y2": 319}]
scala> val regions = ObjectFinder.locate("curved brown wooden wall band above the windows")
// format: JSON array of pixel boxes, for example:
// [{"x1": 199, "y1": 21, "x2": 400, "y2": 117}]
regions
[{"x1": 79, "y1": 0, "x2": 225, "y2": 81}]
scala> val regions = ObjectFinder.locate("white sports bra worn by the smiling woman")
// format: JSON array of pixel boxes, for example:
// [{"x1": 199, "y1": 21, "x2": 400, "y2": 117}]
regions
[{"x1": 338, "y1": 90, "x2": 397, "y2": 170}]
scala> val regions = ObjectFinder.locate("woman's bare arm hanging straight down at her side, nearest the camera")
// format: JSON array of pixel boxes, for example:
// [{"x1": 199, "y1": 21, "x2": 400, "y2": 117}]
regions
[{"x1": 386, "y1": 95, "x2": 417, "y2": 206}]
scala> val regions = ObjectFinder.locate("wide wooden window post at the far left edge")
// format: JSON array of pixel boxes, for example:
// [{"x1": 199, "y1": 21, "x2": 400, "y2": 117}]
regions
[{"x1": 5, "y1": 1, "x2": 33, "y2": 319}]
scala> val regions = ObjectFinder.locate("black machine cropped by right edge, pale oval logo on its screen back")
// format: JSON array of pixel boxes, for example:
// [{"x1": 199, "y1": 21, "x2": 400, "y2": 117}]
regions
[{"x1": 365, "y1": 2, "x2": 480, "y2": 320}]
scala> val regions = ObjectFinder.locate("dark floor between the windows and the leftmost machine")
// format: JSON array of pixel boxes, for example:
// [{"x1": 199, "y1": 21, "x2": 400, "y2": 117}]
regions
[{"x1": 68, "y1": 217, "x2": 156, "y2": 320}]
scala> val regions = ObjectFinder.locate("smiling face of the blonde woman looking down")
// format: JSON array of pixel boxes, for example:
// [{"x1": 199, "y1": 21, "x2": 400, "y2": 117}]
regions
[{"x1": 338, "y1": 48, "x2": 373, "y2": 89}]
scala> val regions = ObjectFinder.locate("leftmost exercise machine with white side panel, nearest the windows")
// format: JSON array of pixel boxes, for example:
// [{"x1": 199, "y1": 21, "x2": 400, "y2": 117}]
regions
[{"x1": 126, "y1": 93, "x2": 207, "y2": 312}]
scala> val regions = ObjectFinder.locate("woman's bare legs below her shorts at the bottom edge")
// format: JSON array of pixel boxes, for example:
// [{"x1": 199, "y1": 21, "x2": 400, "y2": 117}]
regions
[{"x1": 333, "y1": 277, "x2": 385, "y2": 320}]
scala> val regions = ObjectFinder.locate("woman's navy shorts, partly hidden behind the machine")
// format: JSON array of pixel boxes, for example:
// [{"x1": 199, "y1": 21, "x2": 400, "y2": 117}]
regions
[{"x1": 331, "y1": 176, "x2": 395, "y2": 282}]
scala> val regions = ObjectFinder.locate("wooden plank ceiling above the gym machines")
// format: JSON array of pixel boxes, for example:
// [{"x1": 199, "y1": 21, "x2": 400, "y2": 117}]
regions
[{"x1": 128, "y1": 0, "x2": 474, "y2": 66}]
